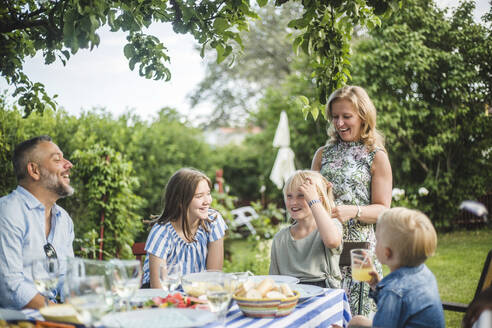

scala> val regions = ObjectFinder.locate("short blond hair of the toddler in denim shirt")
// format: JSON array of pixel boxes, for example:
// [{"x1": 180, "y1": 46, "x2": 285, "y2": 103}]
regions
[{"x1": 376, "y1": 207, "x2": 437, "y2": 267}]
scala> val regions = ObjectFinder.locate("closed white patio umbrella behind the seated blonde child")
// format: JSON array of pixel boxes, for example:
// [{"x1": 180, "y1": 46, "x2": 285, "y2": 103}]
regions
[{"x1": 270, "y1": 111, "x2": 296, "y2": 189}]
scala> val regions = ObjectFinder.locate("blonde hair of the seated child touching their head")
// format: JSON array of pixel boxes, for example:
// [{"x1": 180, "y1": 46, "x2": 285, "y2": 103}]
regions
[{"x1": 284, "y1": 170, "x2": 335, "y2": 216}]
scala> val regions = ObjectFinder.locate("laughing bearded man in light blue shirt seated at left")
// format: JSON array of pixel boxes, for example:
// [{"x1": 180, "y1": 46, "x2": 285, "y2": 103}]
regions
[{"x1": 0, "y1": 135, "x2": 74, "y2": 310}]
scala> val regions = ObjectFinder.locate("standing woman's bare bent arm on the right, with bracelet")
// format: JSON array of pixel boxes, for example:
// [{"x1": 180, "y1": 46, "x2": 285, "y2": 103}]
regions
[{"x1": 332, "y1": 151, "x2": 393, "y2": 223}]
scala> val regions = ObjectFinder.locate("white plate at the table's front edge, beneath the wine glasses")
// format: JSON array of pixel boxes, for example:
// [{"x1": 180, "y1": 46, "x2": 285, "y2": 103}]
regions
[{"x1": 101, "y1": 308, "x2": 216, "y2": 328}]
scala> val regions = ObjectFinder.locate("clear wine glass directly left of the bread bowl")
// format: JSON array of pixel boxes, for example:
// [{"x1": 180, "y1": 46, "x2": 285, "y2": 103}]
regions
[{"x1": 205, "y1": 271, "x2": 233, "y2": 327}]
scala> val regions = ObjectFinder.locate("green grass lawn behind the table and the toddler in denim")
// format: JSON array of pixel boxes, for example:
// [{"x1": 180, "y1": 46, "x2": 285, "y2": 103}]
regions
[{"x1": 227, "y1": 229, "x2": 492, "y2": 328}]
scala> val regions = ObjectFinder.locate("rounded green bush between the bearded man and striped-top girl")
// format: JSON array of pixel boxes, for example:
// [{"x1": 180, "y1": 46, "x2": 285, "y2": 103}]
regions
[{"x1": 64, "y1": 144, "x2": 145, "y2": 258}]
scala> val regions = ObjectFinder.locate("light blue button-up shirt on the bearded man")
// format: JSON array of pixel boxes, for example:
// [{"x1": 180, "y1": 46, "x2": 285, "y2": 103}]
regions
[{"x1": 0, "y1": 186, "x2": 74, "y2": 309}]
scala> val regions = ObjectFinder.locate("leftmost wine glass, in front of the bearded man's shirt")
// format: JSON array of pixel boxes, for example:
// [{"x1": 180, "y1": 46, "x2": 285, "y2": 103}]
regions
[{"x1": 31, "y1": 257, "x2": 60, "y2": 306}]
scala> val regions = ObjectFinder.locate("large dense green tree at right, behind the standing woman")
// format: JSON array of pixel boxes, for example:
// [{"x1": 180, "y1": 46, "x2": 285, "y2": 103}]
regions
[{"x1": 353, "y1": 0, "x2": 492, "y2": 225}]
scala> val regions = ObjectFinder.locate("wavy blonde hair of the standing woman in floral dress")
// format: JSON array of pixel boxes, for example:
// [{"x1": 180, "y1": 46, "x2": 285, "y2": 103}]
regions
[{"x1": 326, "y1": 85, "x2": 385, "y2": 151}]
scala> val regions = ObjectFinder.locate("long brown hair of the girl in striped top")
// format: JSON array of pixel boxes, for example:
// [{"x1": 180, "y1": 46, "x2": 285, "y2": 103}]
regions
[{"x1": 157, "y1": 168, "x2": 212, "y2": 241}]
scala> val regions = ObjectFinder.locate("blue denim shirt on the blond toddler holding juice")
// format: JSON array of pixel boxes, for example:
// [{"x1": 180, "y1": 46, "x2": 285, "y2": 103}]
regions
[{"x1": 370, "y1": 264, "x2": 444, "y2": 328}]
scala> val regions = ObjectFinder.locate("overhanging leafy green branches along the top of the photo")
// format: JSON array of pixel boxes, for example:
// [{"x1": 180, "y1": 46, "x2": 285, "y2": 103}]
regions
[{"x1": 0, "y1": 0, "x2": 399, "y2": 115}]
